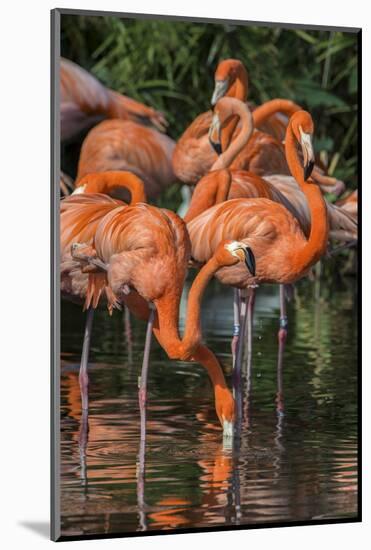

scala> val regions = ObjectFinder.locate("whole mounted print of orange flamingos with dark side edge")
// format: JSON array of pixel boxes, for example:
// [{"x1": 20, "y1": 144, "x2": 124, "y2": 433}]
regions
[{"x1": 52, "y1": 9, "x2": 361, "y2": 540}]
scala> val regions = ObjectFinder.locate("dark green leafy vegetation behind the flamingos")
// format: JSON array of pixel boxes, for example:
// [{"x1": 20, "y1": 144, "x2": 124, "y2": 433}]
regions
[{"x1": 62, "y1": 15, "x2": 358, "y2": 208}]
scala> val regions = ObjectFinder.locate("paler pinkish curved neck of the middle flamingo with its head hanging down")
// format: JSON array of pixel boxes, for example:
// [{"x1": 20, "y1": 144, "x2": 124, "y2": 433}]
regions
[{"x1": 210, "y1": 101, "x2": 254, "y2": 170}]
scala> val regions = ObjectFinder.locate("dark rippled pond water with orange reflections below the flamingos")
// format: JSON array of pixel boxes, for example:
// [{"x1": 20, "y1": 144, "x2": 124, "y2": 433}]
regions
[{"x1": 61, "y1": 278, "x2": 357, "y2": 536}]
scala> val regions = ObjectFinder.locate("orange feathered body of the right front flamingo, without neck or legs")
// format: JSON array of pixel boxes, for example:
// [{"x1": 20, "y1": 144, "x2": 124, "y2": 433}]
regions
[{"x1": 187, "y1": 198, "x2": 309, "y2": 288}]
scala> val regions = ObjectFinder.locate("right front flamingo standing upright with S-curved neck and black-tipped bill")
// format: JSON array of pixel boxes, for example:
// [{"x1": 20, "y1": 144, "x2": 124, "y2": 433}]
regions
[{"x1": 187, "y1": 111, "x2": 329, "y2": 388}]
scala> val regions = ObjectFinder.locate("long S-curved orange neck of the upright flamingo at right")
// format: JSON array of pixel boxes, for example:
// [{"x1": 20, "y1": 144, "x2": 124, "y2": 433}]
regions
[{"x1": 285, "y1": 123, "x2": 329, "y2": 272}]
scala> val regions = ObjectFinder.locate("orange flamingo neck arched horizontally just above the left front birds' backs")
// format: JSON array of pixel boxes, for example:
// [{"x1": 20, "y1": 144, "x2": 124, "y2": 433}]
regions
[{"x1": 77, "y1": 171, "x2": 147, "y2": 205}]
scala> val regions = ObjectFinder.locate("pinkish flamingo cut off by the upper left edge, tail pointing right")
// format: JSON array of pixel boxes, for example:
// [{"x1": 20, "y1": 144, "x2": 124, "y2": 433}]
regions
[{"x1": 60, "y1": 58, "x2": 167, "y2": 141}]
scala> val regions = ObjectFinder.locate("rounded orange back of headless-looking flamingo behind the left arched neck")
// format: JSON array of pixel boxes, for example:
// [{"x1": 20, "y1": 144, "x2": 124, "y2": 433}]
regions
[{"x1": 76, "y1": 119, "x2": 175, "y2": 202}]
